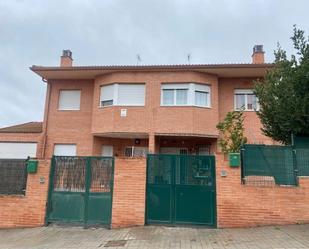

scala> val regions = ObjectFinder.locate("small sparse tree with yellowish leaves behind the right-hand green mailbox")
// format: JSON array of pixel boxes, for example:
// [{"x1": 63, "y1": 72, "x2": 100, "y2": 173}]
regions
[{"x1": 217, "y1": 111, "x2": 247, "y2": 154}]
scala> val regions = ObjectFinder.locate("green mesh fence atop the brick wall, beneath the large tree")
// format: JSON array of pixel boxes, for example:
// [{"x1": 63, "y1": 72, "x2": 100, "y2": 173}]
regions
[{"x1": 241, "y1": 138, "x2": 309, "y2": 186}]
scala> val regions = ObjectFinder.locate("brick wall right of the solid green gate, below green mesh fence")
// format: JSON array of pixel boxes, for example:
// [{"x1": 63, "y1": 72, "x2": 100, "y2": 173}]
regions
[{"x1": 216, "y1": 154, "x2": 309, "y2": 228}]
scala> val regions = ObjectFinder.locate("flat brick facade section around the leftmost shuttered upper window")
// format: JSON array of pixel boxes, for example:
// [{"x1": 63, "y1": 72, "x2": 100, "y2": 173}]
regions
[{"x1": 45, "y1": 80, "x2": 93, "y2": 158}]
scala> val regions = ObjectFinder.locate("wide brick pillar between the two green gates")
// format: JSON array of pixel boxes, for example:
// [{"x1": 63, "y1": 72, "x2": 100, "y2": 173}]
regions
[{"x1": 112, "y1": 158, "x2": 146, "y2": 228}]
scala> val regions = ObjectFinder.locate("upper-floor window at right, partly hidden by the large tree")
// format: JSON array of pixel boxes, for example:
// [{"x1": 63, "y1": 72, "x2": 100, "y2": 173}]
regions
[{"x1": 234, "y1": 89, "x2": 260, "y2": 111}]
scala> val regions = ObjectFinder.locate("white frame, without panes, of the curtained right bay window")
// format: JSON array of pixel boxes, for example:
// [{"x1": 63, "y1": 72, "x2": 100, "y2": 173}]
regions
[{"x1": 161, "y1": 83, "x2": 211, "y2": 108}]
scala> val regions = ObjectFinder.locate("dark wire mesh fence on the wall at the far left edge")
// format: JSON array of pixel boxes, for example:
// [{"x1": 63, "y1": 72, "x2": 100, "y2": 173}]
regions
[{"x1": 0, "y1": 159, "x2": 27, "y2": 195}]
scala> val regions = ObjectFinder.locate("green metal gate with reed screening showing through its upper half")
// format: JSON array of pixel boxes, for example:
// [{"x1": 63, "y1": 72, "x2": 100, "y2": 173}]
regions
[{"x1": 46, "y1": 156, "x2": 114, "y2": 226}]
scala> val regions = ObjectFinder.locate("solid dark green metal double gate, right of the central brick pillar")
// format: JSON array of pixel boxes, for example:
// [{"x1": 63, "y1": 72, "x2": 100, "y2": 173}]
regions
[{"x1": 146, "y1": 154, "x2": 216, "y2": 226}]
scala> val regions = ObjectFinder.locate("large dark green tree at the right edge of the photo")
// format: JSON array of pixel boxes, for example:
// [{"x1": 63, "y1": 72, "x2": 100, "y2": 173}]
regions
[{"x1": 255, "y1": 25, "x2": 309, "y2": 144}]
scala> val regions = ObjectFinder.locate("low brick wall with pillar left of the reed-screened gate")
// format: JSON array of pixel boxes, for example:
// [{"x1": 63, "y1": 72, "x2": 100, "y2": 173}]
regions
[{"x1": 0, "y1": 160, "x2": 50, "y2": 228}]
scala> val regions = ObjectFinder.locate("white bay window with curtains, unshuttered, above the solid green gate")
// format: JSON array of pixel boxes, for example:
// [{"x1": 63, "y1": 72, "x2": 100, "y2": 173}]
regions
[{"x1": 161, "y1": 83, "x2": 210, "y2": 107}]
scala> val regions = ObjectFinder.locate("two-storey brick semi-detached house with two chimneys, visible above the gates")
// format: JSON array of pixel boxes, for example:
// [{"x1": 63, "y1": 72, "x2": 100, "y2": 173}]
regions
[{"x1": 1, "y1": 46, "x2": 272, "y2": 158}]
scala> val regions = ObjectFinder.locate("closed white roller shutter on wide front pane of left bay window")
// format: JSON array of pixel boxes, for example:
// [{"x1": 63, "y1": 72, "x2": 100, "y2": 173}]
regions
[{"x1": 117, "y1": 84, "x2": 145, "y2": 105}]
